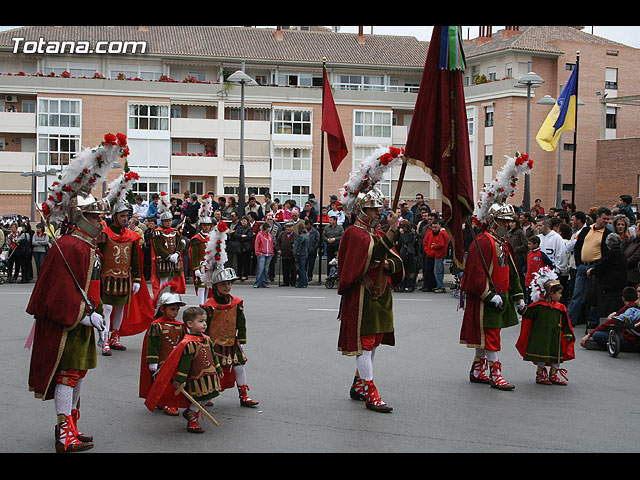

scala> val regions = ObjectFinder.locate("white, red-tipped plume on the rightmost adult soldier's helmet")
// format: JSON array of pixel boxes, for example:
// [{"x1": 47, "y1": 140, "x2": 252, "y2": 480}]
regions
[{"x1": 473, "y1": 152, "x2": 533, "y2": 226}]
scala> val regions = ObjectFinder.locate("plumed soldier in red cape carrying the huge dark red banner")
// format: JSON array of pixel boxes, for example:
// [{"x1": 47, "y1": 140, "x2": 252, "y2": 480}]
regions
[{"x1": 338, "y1": 149, "x2": 404, "y2": 412}]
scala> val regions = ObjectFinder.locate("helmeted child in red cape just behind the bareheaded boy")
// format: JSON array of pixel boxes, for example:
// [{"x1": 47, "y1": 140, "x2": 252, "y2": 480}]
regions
[{"x1": 139, "y1": 282, "x2": 186, "y2": 415}]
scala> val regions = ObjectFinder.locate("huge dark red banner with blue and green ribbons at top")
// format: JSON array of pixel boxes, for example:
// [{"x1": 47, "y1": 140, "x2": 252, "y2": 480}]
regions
[{"x1": 405, "y1": 25, "x2": 474, "y2": 267}]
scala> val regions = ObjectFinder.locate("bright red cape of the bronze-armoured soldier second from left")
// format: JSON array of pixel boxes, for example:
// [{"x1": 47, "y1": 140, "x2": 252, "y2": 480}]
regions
[{"x1": 103, "y1": 228, "x2": 155, "y2": 337}]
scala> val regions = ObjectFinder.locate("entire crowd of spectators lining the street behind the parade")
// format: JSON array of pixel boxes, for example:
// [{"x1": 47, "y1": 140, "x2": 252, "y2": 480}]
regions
[{"x1": 0, "y1": 192, "x2": 640, "y2": 352}]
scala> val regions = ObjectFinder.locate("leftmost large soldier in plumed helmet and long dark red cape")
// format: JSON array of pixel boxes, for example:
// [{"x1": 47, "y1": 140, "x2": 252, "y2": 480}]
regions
[{"x1": 27, "y1": 134, "x2": 128, "y2": 452}]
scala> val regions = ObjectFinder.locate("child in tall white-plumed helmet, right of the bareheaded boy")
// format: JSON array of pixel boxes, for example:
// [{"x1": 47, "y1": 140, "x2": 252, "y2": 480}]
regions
[{"x1": 201, "y1": 222, "x2": 259, "y2": 407}]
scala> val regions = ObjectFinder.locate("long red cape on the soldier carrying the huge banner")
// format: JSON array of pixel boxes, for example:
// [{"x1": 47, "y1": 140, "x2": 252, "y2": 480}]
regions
[{"x1": 338, "y1": 226, "x2": 404, "y2": 354}]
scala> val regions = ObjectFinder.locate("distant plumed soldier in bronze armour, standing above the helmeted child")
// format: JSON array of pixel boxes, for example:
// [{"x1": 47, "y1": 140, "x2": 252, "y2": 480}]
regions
[{"x1": 151, "y1": 192, "x2": 186, "y2": 297}]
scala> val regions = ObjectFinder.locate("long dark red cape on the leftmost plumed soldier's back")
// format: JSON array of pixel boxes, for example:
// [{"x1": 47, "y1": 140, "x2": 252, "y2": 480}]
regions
[{"x1": 27, "y1": 235, "x2": 99, "y2": 400}]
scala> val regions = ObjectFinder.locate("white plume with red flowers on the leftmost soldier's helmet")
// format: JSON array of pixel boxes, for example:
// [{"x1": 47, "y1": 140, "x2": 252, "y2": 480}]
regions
[{"x1": 42, "y1": 133, "x2": 129, "y2": 224}]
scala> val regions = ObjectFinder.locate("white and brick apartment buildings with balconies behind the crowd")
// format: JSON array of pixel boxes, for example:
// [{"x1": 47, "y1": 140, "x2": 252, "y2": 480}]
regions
[{"x1": 0, "y1": 26, "x2": 640, "y2": 215}]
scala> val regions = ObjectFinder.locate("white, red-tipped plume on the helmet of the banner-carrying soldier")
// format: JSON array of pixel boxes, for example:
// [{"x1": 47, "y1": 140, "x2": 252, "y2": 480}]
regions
[{"x1": 338, "y1": 146, "x2": 404, "y2": 212}]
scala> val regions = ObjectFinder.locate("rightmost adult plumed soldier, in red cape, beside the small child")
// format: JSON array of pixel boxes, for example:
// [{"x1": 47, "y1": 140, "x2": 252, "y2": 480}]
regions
[{"x1": 460, "y1": 155, "x2": 533, "y2": 390}]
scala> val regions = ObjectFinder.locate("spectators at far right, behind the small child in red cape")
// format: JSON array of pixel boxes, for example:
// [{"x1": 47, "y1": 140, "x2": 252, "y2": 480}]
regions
[{"x1": 508, "y1": 195, "x2": 640, "y2": 350}]
